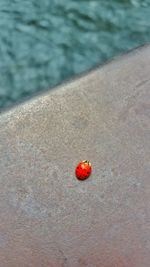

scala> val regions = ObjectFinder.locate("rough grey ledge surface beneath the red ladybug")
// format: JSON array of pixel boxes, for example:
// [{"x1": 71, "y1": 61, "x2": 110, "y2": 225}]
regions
[{"x1": 0, "y1": 46, "x2": 150, "y2": 267}]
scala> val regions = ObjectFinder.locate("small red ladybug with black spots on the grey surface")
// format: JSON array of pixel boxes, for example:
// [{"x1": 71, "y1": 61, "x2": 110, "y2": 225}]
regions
[{"x1": 75, "y1": 160, "x2": 92, "y2": 180}]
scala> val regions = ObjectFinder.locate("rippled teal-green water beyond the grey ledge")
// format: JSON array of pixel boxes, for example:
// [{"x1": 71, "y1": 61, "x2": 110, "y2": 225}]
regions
[{"x1": 0, "y1": 0, "x2": 150, "y2": 108}]
